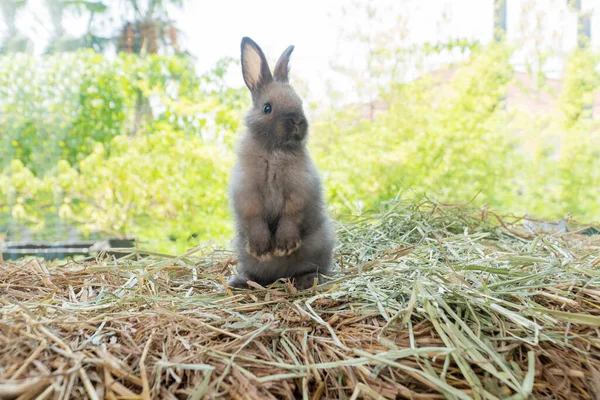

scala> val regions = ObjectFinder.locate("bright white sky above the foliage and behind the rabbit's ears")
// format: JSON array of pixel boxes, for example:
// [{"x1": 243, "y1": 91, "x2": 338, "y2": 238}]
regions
[{"x1": 0, "y1": 0, "x2": 600, "y2": 103}]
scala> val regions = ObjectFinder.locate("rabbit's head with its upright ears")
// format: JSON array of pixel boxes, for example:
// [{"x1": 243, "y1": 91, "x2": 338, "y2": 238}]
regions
[{"x1": 241, "y1": 37, "x2": 308, "y2": 150}]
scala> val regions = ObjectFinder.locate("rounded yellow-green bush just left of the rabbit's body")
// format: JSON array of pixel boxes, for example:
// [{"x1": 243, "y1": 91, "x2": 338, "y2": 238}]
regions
[{"x1": 51, "y1": 127, "x2": 232, "y2": 250}]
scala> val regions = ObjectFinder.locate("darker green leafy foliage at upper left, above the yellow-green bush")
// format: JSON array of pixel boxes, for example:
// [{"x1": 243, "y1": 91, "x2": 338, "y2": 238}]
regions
[{"x1": 0, "y1": 51, "x2": 199, "y2": 174}]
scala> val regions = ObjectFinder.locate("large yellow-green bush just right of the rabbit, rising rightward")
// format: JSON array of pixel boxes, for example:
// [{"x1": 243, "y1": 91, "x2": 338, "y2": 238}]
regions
[{"x1": 314, "y1": 42, "x2": 515, "y2": 211}]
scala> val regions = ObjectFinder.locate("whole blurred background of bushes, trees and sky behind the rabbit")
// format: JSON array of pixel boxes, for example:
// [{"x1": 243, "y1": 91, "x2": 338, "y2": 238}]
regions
[{"x1": 0, "y1": 0, "x2": 600, "y2": 253}]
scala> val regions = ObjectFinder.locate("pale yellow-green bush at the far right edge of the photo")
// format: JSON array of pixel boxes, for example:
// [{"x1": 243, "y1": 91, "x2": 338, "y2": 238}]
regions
[{"x1": 518, "y1": 49, "x2": 600, "y2": 220}]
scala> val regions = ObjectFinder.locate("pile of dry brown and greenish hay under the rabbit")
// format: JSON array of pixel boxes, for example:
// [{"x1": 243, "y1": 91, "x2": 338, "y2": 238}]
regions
[{"x1": 0, "y1": 203, "x2": 600, "y2": 399}]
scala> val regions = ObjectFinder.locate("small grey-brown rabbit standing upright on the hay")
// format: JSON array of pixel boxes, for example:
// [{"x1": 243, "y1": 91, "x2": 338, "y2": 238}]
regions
[{"x1": 228, "y1": 37, "x2": 335, "y2": 290}]
